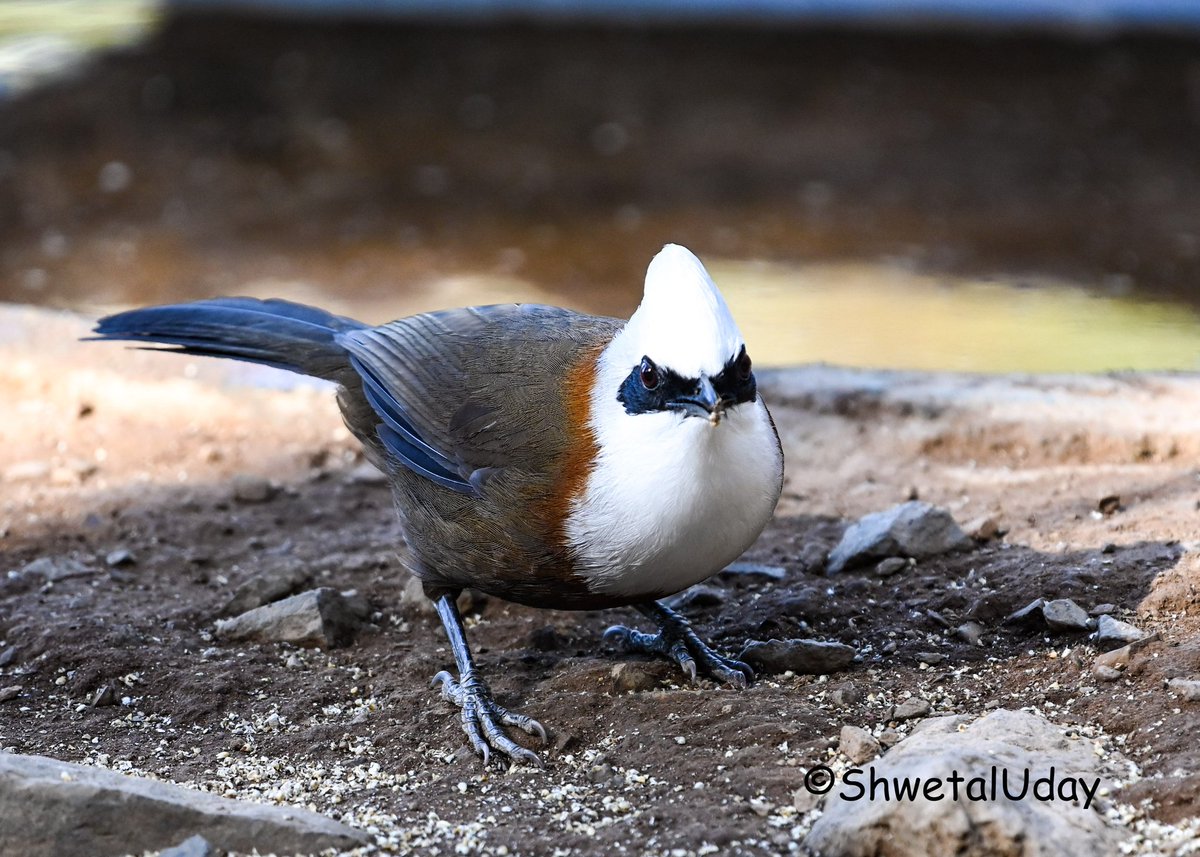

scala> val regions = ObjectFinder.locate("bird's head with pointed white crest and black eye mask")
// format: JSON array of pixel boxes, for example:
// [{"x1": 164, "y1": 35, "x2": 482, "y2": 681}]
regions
[{"x1": 602, "y1": 244, "x2": 757, "y2": 426}]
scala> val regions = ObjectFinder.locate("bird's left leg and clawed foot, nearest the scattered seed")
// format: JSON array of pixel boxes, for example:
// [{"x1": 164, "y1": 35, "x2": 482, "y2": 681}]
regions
[{"x1": 433, "y1": 593, "x2": 546, "y2": 767}]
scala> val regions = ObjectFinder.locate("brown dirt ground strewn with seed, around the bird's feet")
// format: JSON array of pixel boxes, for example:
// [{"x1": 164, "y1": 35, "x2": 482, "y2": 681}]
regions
[{"x1": 0, "y1": 303, "x2": 1200, "y2": 853}]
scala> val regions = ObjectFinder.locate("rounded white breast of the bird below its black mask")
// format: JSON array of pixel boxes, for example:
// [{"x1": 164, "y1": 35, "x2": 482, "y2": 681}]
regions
[{"x1": 566, "y1": 388, "x2": 784, "y2": 598}]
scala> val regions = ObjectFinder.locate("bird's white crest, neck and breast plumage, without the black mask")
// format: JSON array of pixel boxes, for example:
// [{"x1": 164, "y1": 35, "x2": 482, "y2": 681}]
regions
[{"x1": 566, "y1": 245, "x2": 784, "y2": 599}]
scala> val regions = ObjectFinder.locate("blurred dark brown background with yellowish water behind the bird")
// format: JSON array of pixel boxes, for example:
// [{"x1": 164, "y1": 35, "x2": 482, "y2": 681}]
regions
[{"x1": 0, "y1": 0, "x2": 1200, "y2": 370}]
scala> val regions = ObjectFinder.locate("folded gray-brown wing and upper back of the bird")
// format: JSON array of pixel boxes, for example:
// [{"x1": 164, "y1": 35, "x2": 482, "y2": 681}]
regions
[{"x1": 337, "y1": 304, "x2": 623, "y2": 496}]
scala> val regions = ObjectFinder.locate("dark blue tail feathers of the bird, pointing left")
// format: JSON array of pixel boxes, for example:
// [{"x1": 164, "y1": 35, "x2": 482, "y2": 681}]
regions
[{"x1": 90, "y1": 298, "x2": 367, "y2": 380}]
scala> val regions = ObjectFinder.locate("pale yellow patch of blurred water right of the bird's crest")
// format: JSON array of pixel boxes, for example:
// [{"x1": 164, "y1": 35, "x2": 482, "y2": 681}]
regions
[{"x1": 710, "y1": 256, "x2": 1200, "y2": 372}]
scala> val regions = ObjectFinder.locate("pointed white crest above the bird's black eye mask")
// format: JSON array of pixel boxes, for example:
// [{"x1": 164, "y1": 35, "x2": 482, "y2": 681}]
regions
[{"x1": 610, "y1": 244, "x2": 743, "y2": 378}]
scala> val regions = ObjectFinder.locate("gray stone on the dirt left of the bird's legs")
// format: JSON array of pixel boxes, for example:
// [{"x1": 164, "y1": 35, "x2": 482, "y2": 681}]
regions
[{"x1": 216, "y1": 587, "x2": 361, "y2": 646}]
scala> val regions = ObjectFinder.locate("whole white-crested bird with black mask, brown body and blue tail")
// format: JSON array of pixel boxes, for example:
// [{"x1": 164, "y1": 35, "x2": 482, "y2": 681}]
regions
[{"x1": 89, "y1": 244, "x2": 784, "y2": 767}]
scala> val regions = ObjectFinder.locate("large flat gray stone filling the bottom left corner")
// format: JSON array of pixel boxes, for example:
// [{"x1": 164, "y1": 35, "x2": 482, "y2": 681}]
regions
[{"x1": 0, "y1": 753, "x2": 370, "y2": 857}]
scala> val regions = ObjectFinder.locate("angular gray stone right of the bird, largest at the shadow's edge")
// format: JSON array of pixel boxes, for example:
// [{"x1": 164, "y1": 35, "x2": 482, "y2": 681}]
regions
[{"x1": 826, "y1": 501, "x2": 973, "y2": 574}]
